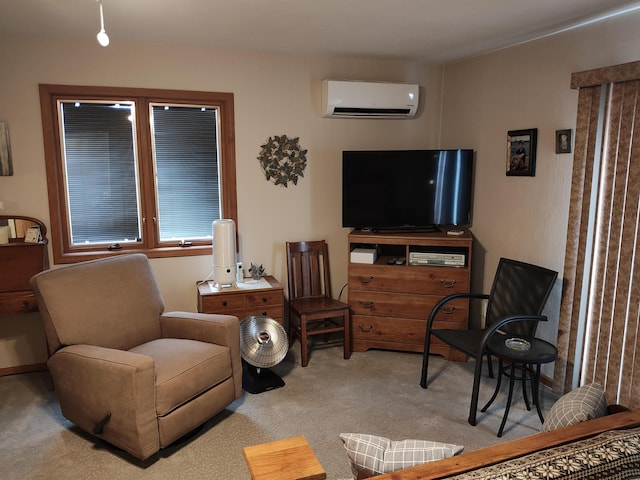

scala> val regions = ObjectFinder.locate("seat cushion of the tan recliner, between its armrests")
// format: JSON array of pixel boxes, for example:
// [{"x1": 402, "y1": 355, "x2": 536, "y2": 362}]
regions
[{"x1": 129, "y1": 338, "x2": 231, "y2": 416}]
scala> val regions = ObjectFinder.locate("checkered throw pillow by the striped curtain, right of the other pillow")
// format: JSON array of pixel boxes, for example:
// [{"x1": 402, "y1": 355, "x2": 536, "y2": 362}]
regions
[{"x1": 542, "y1": 383, "x2": 607, "y2": 432}]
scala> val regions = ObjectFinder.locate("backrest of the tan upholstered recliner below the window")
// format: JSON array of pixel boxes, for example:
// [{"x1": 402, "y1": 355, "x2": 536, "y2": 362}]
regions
[{"x1": 31, "y1": 254, "x2": 164, "y2": 353}]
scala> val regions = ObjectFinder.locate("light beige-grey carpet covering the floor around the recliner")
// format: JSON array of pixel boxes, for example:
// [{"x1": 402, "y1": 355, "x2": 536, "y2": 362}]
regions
[{"x1": 0, "y1": 342, "x2": 555, "y2": 480}]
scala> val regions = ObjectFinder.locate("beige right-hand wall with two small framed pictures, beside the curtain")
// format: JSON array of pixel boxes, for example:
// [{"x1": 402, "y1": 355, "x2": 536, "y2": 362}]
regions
[{"x1": 442, "y1": 13, "x2": 640, "y2": 368}]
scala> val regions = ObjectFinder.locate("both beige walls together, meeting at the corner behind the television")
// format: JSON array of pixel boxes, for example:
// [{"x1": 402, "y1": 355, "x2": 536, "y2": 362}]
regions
[{"x1": 0, "y1": 9, "x2": 640, "y2": 368}]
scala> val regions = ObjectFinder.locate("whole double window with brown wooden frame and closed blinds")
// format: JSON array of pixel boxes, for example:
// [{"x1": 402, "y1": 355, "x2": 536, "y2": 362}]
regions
[{"x1": 40, "y1": 85, "x2": 237, "y2": 263}]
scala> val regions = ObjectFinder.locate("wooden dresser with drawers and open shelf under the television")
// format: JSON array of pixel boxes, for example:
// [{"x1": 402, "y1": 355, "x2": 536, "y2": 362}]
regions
[{"x1": 349, "y1": 231, "x2": 473, "y2": 361}]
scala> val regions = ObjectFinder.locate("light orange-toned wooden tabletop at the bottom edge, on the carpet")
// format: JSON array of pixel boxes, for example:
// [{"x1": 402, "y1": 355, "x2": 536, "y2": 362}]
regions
[{"x1": 242, "y1": 436, "x2": 327, "y2": 480}]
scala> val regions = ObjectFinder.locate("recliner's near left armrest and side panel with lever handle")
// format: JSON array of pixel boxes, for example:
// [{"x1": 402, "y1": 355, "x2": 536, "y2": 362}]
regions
[{"x1": 47, "y1": 345, "x2": 159, "y2": 459}]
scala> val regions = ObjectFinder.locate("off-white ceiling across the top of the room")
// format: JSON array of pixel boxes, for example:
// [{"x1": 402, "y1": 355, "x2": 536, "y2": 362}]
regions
[{"x1": 0, "y1": 0, "x2": 640, "y2": 63}]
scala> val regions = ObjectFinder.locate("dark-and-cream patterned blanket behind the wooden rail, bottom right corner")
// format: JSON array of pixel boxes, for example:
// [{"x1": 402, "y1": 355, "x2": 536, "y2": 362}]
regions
[{"x1": 448, "y1": 427, "x2": 640, "y2": 480}]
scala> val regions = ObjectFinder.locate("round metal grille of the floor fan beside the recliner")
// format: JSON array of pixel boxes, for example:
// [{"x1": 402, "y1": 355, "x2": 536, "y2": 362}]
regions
[{"x1": 240, "y1": 315, "x2": 289, "y2": 368}]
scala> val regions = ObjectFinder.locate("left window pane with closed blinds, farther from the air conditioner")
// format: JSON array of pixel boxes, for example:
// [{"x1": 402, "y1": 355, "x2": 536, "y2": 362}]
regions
[{"x1": 60, "y1": 101, "x2": 142, "y2": 245}]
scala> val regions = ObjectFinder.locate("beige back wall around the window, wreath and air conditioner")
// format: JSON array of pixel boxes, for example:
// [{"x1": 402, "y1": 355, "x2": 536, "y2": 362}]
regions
[{"x1": 0, "y1": 36, "x2": 441, "y2": 368}]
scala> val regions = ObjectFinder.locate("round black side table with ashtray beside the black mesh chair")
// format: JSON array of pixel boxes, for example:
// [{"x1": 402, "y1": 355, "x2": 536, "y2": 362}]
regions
[{"x1": 481, "y1": 334, "x2": 558, "y2": 437}]
